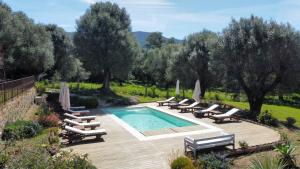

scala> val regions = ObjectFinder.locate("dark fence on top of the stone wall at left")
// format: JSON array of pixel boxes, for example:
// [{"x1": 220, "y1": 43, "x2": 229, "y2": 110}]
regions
[{"x1": 0, "y1": 76, "x2": 34, "y2": 104}]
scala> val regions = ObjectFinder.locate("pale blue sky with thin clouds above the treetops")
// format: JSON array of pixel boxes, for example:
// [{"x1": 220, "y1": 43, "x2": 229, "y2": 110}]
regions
[{"x1": 2, "y1": 0, "x2": 300, "y2": 39}]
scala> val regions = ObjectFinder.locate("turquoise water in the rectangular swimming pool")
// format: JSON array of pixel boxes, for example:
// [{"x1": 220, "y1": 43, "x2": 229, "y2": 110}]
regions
[{"x1": 104, "y1": 107, "x2": 196, "y2": 132}]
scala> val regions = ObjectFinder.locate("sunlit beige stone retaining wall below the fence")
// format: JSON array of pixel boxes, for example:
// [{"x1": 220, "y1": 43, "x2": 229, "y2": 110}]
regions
[{"x1": 0, "y1": 88, "x2": 36, "y2": 130}]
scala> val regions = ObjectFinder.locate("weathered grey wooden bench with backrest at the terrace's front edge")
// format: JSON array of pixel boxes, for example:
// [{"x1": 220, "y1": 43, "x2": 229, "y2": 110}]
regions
[{"x1": 184, "y1": 133, "x2": 235, "y2": 158}]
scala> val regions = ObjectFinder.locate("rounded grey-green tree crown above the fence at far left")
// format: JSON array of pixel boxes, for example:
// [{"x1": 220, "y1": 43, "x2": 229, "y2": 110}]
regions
[{"x1": 3, "y1": 12, "x2": 54, "y2": 78}]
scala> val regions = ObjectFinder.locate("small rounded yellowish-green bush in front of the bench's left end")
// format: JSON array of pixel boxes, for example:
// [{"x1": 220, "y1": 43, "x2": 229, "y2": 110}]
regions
[{"x1": 197, "y1": 153, "x2": 229, "y2": 169}]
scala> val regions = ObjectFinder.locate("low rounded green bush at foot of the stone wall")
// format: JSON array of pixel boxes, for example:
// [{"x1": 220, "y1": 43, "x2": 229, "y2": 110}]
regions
[{"x1": 2, "y1": 120, "x2": 42, "y2": 140}]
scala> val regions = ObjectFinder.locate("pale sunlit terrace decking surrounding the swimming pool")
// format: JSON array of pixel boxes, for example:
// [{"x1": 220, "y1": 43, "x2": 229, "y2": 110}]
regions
[{"x1": 69, "y1": 103, "x2": 280, "y2": 169}]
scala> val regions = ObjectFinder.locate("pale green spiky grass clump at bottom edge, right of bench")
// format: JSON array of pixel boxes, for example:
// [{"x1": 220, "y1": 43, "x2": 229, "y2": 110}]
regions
[{"x1": 249, "y1": 156, "x2": 285, "y2": 169}]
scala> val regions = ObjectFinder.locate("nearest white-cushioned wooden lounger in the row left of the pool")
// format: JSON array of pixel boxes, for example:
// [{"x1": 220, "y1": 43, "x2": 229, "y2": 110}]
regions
[{"x1": 63, "y1": 126, "x2": 107, "y2": 143}]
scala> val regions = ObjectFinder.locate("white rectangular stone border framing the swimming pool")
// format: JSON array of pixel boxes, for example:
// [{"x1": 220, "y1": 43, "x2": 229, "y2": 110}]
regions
[{"x1": 101, "y1": 105, "x2": 223, "y2": 141}]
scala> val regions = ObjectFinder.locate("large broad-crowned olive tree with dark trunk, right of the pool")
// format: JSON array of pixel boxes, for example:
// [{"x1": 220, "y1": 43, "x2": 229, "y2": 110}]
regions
[{"x1": 220, "y1": 16, "x2": 299, "y2": 117}]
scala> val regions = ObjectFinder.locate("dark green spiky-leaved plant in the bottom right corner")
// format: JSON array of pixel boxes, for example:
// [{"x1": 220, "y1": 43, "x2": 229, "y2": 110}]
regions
[{"x1": 275, "y1": 143, "x2": 296, "y2": 168}]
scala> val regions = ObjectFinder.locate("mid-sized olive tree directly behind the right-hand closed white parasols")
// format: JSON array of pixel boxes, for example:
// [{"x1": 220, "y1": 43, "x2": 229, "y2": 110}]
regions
[{"x1": 171, "y1": 30, "x2": 218, "y2": 97}]
